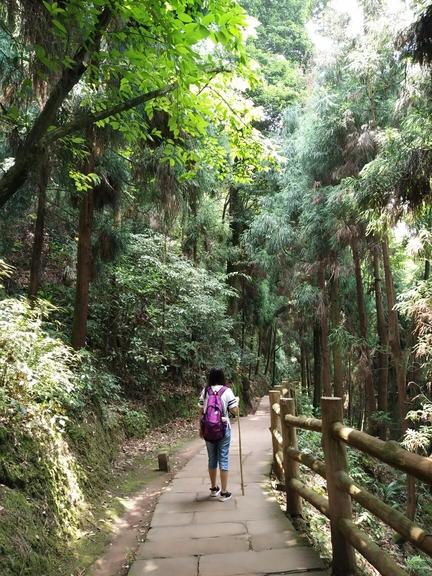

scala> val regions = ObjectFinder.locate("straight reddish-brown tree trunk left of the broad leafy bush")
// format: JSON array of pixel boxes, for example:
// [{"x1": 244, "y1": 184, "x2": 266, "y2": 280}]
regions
[{"x1": 72, "y1": 190, "x2": 93, "y2": 350}]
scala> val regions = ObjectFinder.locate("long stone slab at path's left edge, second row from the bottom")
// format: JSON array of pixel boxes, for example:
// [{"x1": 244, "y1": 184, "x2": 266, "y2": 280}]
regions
[{"x1": 137, "y1": 535, "x2": 249, "y2": 559}]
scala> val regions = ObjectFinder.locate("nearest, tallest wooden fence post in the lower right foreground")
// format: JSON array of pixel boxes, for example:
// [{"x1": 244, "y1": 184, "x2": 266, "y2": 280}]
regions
[{"x1": 321, "y1": 398, "x2": 356, "y2": 576}]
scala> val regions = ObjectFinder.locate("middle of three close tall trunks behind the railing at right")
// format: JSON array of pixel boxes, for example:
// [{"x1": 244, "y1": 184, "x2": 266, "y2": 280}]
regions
[{"x1": 371, "y1": 244, "x2": 389, "y2": 440}]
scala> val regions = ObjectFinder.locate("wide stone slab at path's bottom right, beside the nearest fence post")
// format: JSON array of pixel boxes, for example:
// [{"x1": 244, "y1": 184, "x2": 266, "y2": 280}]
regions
[{"x1": 200, "y1": 546, "x2": 324, "y2": 576}]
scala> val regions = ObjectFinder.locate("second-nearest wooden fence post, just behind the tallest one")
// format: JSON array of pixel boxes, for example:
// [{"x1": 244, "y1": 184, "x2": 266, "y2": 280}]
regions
[{"x1": 280, "y1": 398, "x2": 302, "y2": 516}]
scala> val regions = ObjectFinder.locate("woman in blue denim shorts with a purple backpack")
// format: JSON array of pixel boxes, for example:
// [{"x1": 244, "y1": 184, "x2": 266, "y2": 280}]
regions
[{"x1": 199, "y1": 368, "x2": 238, "y2": 502}]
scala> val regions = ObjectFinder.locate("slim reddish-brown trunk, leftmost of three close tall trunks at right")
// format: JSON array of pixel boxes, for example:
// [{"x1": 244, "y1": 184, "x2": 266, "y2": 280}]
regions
[{"x1": 351, "y1": 236, "x2": 376, "y2": 432}]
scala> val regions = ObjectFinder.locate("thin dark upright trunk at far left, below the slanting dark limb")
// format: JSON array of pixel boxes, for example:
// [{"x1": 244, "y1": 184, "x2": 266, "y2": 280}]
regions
[{"x1": 29, "y1": 157, "x2": 49, "y2": 302}]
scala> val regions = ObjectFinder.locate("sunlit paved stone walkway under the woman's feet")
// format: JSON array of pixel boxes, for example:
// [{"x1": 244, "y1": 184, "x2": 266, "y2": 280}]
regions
[{"x1": 129, "y1": 398, "x2": 326, "y2": 576}]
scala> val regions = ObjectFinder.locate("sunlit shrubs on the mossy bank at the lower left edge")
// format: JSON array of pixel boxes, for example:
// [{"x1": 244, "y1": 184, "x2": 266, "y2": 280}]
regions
[{"x1": 0, "y1": 299, "x2": 120, "y2": 576}]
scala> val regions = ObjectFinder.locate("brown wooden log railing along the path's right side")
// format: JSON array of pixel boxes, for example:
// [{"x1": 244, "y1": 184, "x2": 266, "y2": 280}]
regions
[{"x1": 270, "y1": 385, "x2": 432, "y2": 576}]
